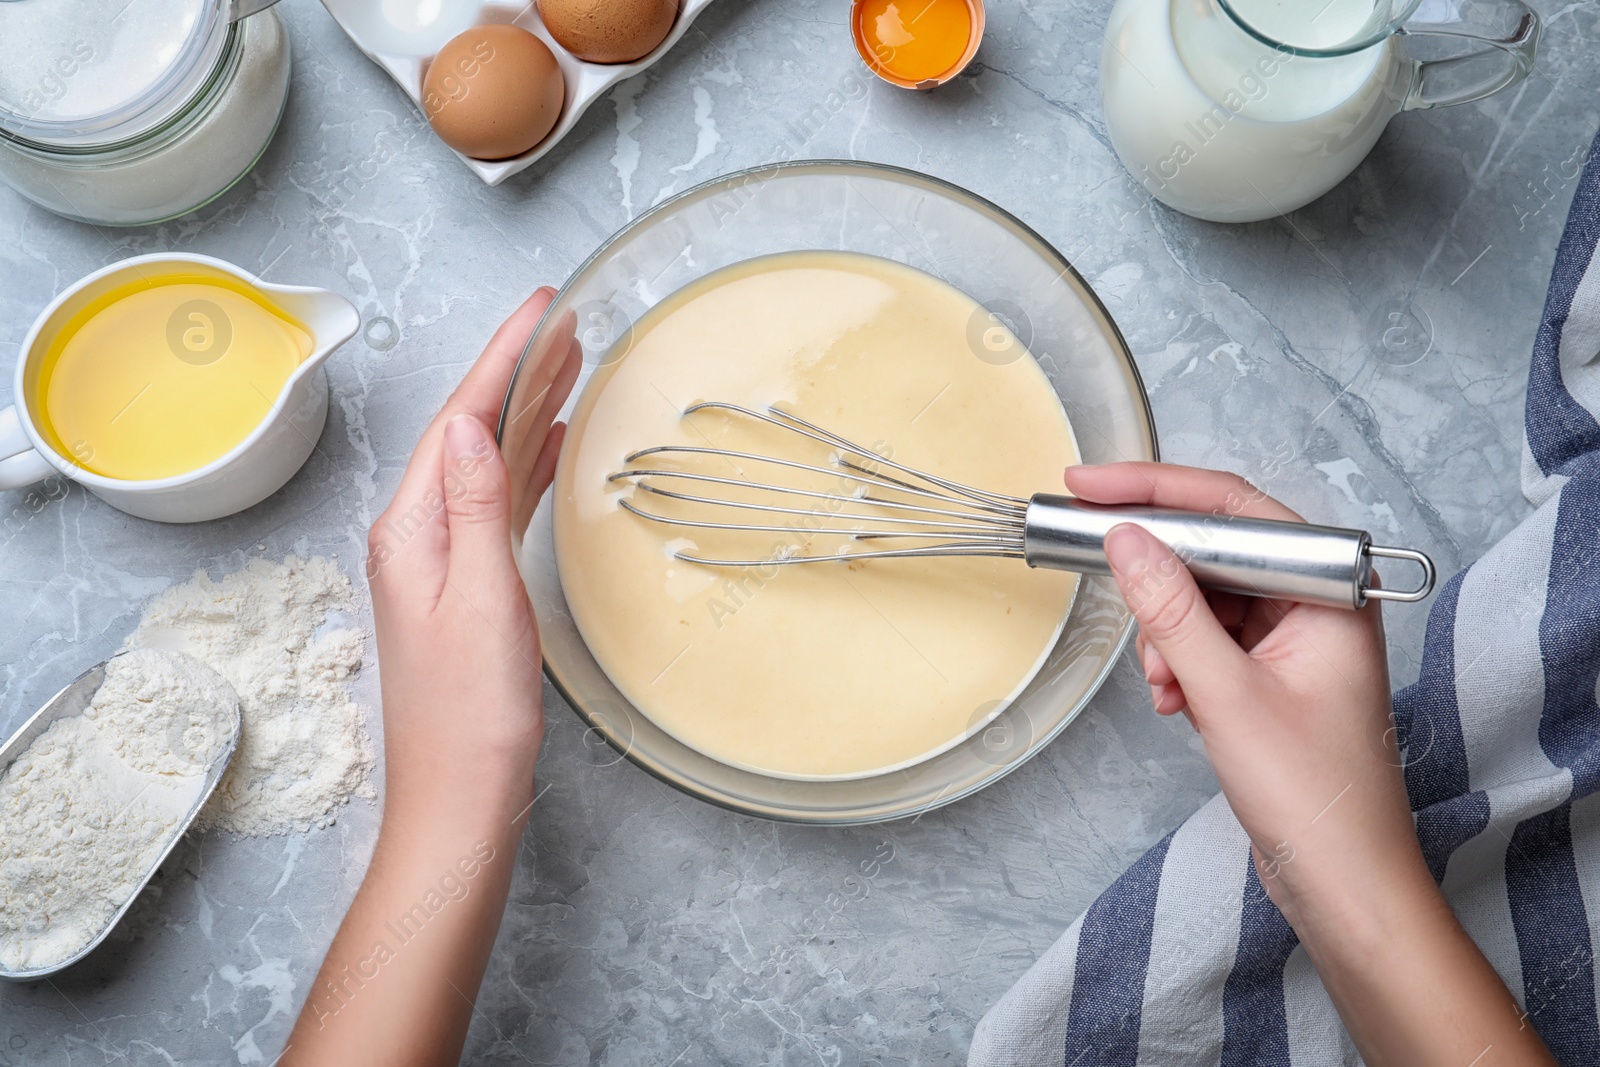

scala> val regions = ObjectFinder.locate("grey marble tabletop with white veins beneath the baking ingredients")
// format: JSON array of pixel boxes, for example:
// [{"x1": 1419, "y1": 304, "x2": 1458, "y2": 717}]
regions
[{"x1": 0, "y1": 0, "x2": 1600, "y2": 1067}]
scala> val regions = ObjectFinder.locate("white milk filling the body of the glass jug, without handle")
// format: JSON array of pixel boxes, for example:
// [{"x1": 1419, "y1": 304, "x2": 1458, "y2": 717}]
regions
[{"x1": 1101, "y1": 0, "x2": 1414, "y2": 222}]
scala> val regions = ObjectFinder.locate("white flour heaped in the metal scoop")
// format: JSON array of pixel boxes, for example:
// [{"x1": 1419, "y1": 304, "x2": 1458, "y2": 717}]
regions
[{"x1": 0, "y1": 651, "x2": 238, "y2": 971}]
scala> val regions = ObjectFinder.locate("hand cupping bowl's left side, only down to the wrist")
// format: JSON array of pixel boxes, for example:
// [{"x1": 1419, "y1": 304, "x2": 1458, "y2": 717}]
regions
[{"x1": 366, "y1": 288, "x2": 578, "y2": 830}]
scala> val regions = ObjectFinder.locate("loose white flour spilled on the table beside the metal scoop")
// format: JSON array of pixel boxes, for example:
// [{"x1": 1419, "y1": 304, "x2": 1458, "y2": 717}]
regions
[{"x1": 128, "y1": 557, "x2": 376, "y2": 835}]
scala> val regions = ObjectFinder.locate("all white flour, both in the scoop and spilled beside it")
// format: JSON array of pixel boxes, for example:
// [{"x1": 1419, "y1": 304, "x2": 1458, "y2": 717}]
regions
[{"x1": 0, "y1": 557, "x2": 374, "y2": 971}]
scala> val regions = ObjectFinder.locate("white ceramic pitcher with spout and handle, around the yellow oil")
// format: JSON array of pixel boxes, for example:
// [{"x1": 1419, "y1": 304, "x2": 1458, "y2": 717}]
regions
[{"x1": 0, "y1": 253, "x2": 360, "y2": 523}]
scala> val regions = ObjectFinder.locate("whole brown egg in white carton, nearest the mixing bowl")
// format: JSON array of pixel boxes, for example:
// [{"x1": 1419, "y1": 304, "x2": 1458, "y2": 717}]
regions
[{"x1": 422, "y1": 26, "x2": 566, "y2": 160}]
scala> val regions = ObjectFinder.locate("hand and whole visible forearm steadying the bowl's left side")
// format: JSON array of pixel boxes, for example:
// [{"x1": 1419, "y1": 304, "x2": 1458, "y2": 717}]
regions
[{"x1": 282, "y1": 290, "x2": 581, "y2": 1067}]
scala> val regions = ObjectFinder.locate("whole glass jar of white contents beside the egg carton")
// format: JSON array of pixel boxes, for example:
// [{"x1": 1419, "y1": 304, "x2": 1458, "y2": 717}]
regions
[{"x1": 0, "y1": 0, "x2": 290, "y2": 226}]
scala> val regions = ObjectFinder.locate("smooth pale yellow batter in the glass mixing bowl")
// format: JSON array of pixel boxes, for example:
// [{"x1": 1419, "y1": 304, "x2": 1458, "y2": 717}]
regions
[{"x1": 554, "y1": 253, "x2": 1078, "y2": 779}]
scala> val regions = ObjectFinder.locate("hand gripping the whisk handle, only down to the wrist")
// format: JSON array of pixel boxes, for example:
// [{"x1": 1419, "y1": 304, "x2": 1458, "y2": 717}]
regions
[{"x1": 1067, "y1": 464, "x2": 1427, "y2": 923}]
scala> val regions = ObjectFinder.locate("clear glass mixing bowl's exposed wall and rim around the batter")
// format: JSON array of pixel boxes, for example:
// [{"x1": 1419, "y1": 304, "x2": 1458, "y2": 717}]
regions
[{"x1": 499, "y1": 160, "x2": 1157, "y2": 825}]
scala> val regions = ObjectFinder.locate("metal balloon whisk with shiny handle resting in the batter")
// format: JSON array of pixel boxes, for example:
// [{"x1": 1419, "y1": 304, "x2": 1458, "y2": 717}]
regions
[{"x1": 606, "y1": 400, "x2": 1435, "y2": 608}]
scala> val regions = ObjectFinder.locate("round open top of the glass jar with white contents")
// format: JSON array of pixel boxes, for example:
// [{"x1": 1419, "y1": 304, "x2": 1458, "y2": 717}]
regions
[{"x1": 0, "y1": 0, "x2": 229, "y2": 144}]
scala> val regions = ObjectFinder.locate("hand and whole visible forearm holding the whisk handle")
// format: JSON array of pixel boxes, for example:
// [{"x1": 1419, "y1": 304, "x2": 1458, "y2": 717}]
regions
[{"x1": 1066, "y1": 462, "x2": 1555, "y2": 1067}]
